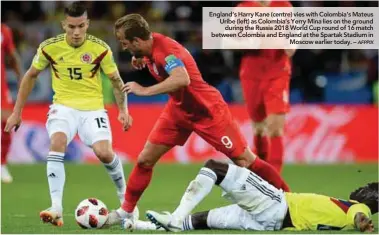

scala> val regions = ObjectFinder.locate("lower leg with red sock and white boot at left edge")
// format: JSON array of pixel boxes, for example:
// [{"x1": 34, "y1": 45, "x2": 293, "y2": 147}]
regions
[{"x1": 1, "y1": 109, "x2": 13, "y2": 183}]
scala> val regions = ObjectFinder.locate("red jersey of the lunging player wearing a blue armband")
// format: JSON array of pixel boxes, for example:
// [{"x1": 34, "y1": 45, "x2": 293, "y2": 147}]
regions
[{"x1": 144, "y1": 33, "x2": 226, "y2": 117}]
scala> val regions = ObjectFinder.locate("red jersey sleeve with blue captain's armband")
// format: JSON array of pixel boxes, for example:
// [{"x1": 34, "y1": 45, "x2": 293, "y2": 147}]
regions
[{"x1": 158, "y1": 43, "x2": 185, "y2": 74}]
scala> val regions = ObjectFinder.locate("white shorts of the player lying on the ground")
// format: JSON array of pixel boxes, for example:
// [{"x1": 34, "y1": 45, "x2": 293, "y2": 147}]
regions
[{"x1": 207, "y1": 164, "x2": 288, "y2": 231}]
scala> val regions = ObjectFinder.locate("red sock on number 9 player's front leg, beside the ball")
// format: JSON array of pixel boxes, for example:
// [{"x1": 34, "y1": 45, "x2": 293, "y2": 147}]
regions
[{"x1": 121, "y1": 164, "x2": 153, "y2": 213}]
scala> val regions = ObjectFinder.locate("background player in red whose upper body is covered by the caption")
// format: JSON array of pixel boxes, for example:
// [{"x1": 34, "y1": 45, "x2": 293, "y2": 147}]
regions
[{"x1": 237, "y1": 1, "x2": 295, "y2": 172}]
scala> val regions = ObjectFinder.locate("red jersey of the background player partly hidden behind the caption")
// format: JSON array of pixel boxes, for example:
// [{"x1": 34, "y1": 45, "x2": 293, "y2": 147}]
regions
[{"x1": 237, "y1": 1, "x2": 292, "y2": 79}]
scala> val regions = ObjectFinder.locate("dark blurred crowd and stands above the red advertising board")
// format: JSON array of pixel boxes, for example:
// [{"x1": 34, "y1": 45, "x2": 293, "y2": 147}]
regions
[{"x1": 2, "y1": 1, "x2": 378, "y2": 104}]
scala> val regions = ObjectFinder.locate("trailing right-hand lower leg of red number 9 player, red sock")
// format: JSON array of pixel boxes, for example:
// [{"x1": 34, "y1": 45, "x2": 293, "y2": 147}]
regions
[{"x1": 230, "y1": 147, "x2": 289, "y2": 191}]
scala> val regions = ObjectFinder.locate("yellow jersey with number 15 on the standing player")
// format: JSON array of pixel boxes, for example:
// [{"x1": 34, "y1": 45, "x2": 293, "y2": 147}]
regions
[{"x1": 32, "y1": 34, "x2": 117, "y2": 110}]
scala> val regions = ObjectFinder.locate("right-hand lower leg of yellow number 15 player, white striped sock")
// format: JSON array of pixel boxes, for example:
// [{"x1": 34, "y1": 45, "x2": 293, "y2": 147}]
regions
[{"x1": 92, "y1": 140, "x2": 126, "y2": 204}]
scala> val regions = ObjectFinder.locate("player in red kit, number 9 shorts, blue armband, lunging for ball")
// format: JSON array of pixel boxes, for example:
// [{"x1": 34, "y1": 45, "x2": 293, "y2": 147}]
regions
[{"x1": 107, "y1": 14, "x2": 289, "y2": 227}]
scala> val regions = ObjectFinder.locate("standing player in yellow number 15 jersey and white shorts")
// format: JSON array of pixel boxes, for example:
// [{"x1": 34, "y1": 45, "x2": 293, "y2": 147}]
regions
[{"x1": 5, "y1": 2, "x2": 132, "y2": 226}]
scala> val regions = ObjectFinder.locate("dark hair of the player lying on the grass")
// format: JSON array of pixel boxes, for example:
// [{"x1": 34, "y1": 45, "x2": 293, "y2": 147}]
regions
[{"x1": 350, "y1": 182, "x2": 379, "y2": 214}]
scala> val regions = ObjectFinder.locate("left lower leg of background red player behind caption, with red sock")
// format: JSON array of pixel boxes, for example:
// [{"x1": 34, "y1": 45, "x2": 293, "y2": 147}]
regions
[{"x1": 253, "y1": 121, "x2": 270, "y2": 161}]
